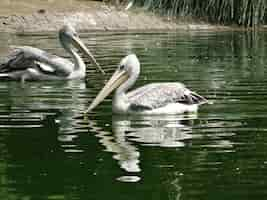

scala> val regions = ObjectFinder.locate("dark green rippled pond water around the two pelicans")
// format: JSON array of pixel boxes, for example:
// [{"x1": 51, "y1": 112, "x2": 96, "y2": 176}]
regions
[{"x1": 0, "y1": 32, "x2": 267, "y2": 200}]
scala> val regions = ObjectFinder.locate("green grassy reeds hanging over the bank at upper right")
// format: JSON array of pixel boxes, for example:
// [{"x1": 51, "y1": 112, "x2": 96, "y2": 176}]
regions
[{"x1": 122, "y1": 0, "x2": 267, "y2": 27}]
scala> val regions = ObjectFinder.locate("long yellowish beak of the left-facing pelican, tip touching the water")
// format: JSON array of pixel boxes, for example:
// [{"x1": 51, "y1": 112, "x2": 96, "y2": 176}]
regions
[{"x1": 85, "y1": 70, "x2": 129, "y2": 113}]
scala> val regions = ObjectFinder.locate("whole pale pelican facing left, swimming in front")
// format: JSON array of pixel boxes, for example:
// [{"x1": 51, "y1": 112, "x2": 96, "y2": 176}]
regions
[{"x1": 85, "y1": 54, "x2": 208, "y2": 114}]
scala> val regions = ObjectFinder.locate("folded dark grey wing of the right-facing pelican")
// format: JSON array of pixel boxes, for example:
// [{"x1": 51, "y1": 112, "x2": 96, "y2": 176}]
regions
[{"x1": 0, "y1": 46, "x2": 73, "y2": 76}]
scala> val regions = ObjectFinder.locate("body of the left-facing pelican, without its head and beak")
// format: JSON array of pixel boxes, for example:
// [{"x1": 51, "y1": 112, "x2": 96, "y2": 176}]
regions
[{"x1": 112, "y1": 82, "x2": 204, "y2": 114}]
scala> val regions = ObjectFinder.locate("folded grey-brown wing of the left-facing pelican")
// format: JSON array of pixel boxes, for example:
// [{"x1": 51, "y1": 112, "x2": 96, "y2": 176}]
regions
[{"x1": 127, "y1": 83, "x2": 207, "y2": 110}]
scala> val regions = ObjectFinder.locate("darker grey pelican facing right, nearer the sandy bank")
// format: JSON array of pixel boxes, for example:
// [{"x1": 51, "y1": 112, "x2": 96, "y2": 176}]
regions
[{"x1": 0, "y1": 25, "x2": 104, "y2": 81}]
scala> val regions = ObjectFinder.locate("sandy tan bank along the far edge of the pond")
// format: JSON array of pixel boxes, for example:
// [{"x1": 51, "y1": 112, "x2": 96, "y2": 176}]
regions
[{"x1": 0, "y1": 0, "x2": 231, "y2": 34}]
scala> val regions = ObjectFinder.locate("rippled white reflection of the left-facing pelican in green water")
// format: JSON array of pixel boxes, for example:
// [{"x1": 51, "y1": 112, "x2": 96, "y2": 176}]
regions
[{"x1": 88, "y1": 113, "x2": 197, "y2": 181}]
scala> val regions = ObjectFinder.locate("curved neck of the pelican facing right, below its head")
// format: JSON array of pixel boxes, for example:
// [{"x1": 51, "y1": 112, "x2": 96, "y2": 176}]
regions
[{"x1": 60, "y1": 37, "x2": 86, "y2": 73}]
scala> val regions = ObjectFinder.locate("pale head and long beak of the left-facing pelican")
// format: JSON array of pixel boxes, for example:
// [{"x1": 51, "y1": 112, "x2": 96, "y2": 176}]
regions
[{"x1": 86, "y1": 54, "x2": 140, "y2": 113}]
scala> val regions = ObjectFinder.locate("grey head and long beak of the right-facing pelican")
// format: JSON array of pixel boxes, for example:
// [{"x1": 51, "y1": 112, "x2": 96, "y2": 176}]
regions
[{"x1": 59, "y1": 24, "x2": 105, "y2": 74}]
